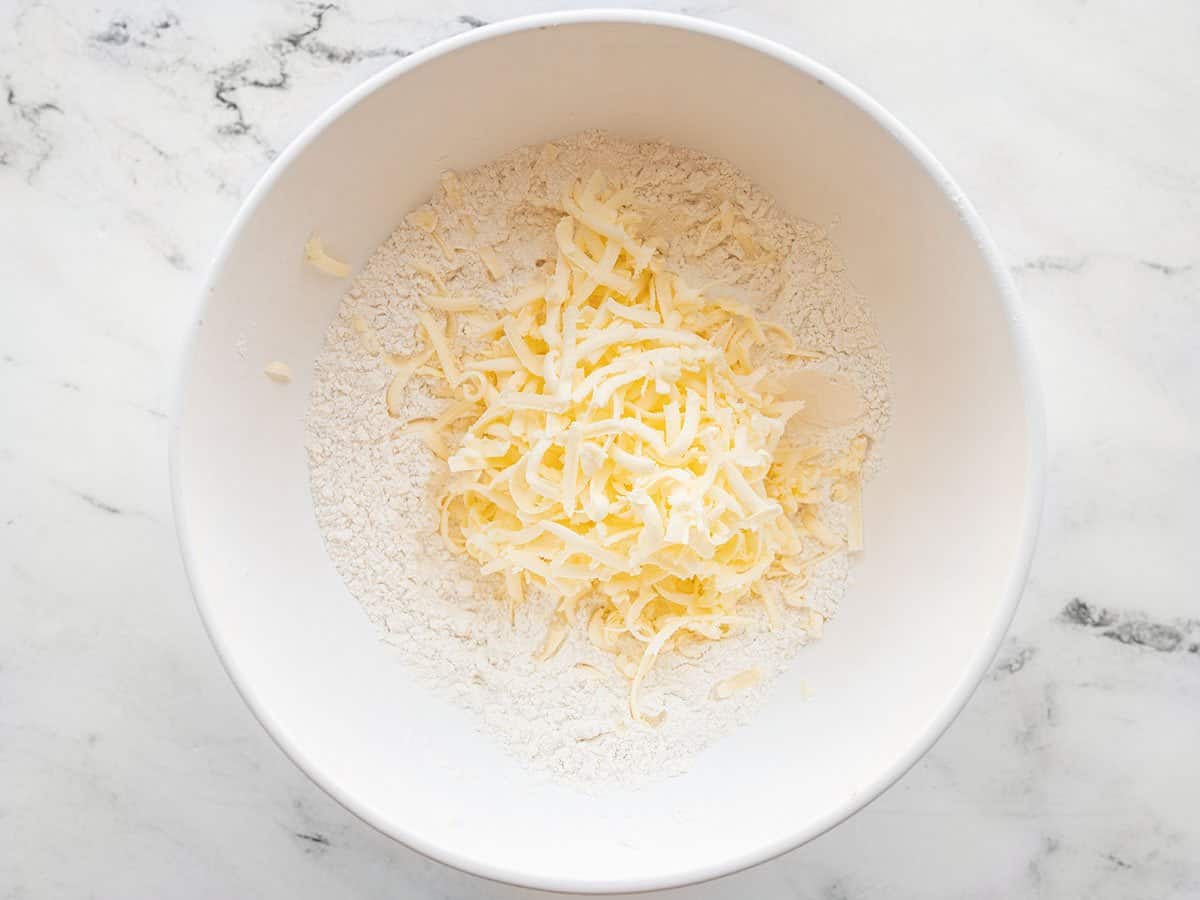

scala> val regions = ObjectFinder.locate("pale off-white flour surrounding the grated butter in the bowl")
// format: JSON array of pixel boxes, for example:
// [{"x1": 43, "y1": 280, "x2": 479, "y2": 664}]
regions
[{"x1": 307, "y1": 132, "x2": 888, "y2": 788}]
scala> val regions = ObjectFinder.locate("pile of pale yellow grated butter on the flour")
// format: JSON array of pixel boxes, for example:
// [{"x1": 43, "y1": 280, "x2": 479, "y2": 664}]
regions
[{"x1": 343, "y1": 173, "x2": 868, "y2": 725}]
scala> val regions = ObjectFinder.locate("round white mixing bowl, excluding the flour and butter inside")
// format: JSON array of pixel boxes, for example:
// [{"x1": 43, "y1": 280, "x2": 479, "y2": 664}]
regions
[{"x1": 172, "y1": 12, "x2": 1042, "y2": 892}]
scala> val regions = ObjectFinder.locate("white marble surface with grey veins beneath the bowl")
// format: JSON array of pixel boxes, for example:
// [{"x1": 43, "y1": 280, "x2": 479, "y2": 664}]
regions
[{"x1": 0, "y1": 0, "x2": 1200, "y2": 900}]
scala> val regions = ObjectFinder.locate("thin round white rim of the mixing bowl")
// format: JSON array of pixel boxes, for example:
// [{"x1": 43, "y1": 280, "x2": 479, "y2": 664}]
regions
[{"x1": 168, "y1": 10, "x2": 1045, "y2": 894}]
